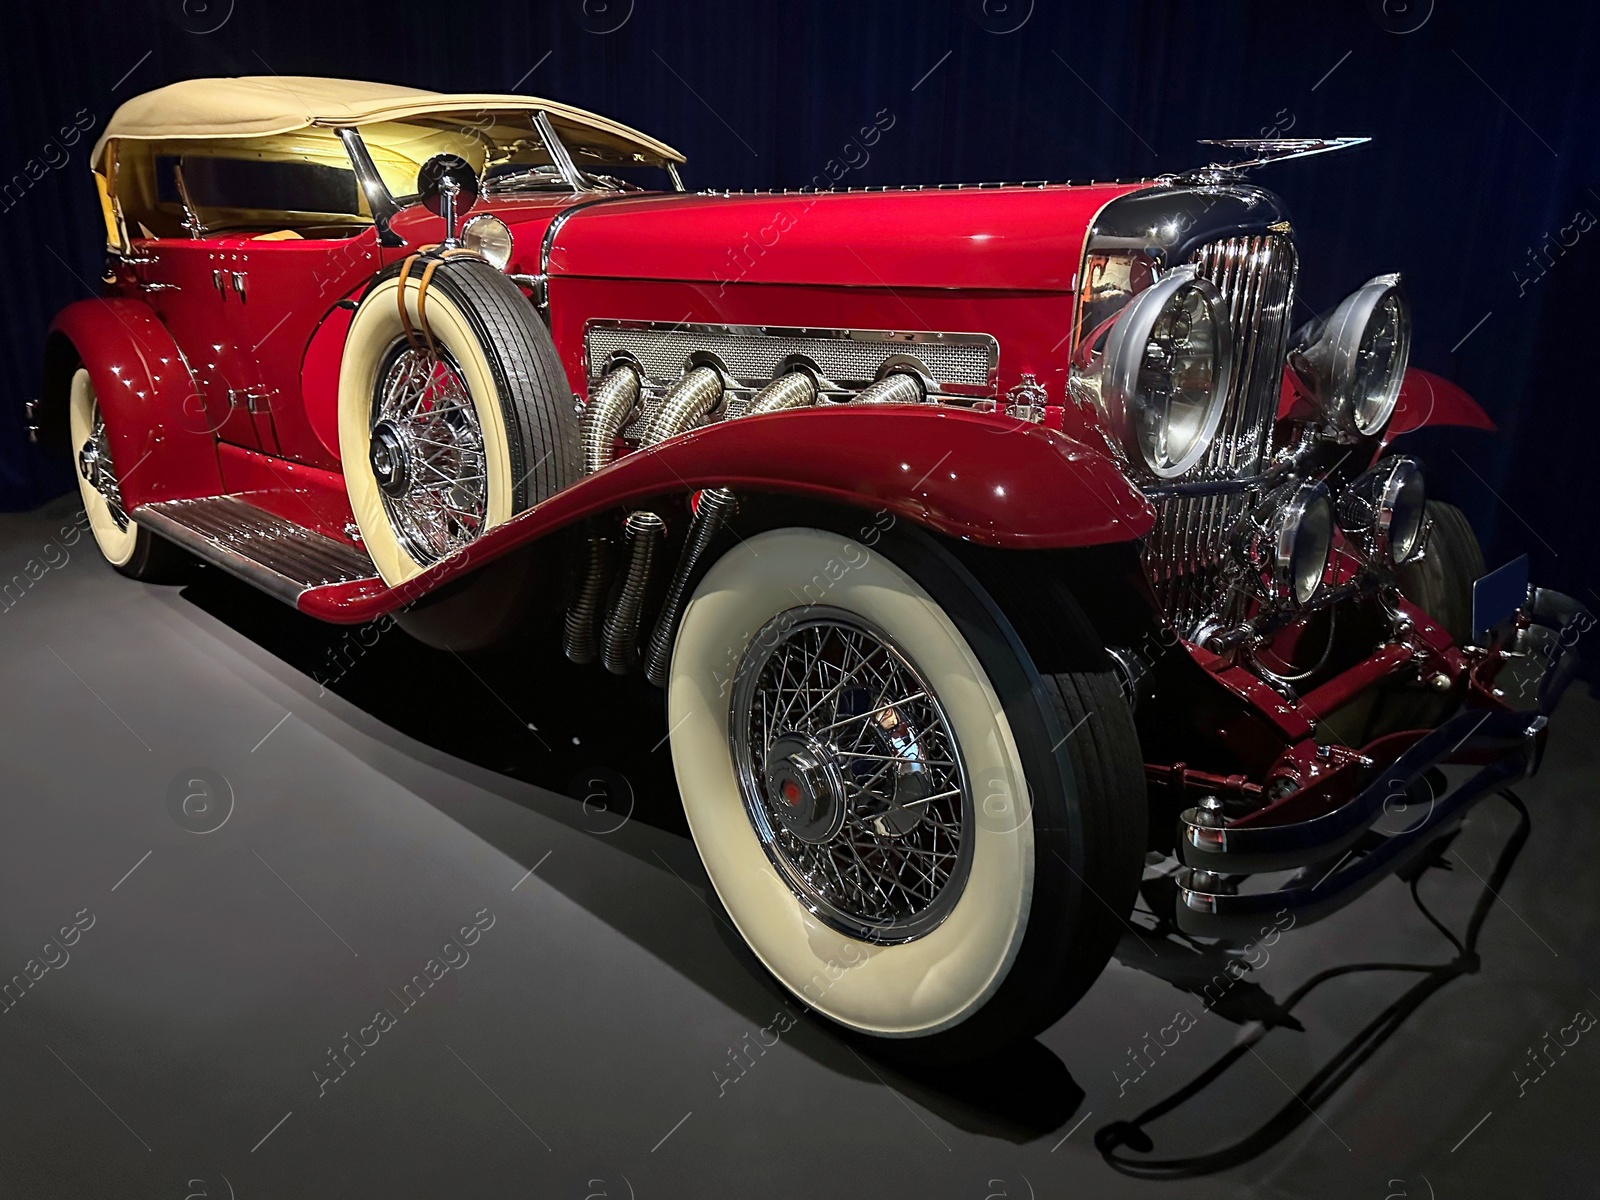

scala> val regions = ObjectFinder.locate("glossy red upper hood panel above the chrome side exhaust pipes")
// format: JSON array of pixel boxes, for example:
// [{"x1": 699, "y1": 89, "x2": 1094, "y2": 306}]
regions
[{"x1": 505, "y1": 184, "x2": 1147, "y2": 291}]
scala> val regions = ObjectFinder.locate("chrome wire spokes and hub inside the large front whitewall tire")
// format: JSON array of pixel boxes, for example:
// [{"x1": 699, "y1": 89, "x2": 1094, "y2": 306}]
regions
[{"x1": 730, "y1": 606, "x2": 973, "y2": 944}]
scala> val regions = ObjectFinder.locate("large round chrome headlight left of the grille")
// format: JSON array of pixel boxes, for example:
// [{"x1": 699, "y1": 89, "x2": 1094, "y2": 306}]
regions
[{"x1": 1101, "y1": 269, "x2": 1234, "y2": 480}]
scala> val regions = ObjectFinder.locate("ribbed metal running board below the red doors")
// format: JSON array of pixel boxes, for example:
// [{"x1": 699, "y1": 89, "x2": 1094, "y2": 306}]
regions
[{"x1": 133, "y1": 496, "x2": 378, "y2": 605}]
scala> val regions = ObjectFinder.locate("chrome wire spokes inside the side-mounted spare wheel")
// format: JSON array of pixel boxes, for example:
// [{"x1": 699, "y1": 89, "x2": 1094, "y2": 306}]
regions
[{"x1": 368, "y1": 339, "x2": 488, "y2": 566}]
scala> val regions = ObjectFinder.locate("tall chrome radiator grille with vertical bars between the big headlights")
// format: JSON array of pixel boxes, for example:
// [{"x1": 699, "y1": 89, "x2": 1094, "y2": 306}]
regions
[{"x1": 1144, "y1": 235, "x2": 1296, "y2": 634}]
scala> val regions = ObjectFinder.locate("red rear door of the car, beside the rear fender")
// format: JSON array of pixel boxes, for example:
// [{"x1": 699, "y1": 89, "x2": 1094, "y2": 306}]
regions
[{"x1": 134, "y1": 237, "x2": 268, "y2": 451}]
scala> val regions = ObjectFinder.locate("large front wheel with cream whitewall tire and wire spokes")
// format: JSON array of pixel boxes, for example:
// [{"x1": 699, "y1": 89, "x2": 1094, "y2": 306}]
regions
[{"x1": 667, "y1": 528, "x2": 1146, "y2": 1058}]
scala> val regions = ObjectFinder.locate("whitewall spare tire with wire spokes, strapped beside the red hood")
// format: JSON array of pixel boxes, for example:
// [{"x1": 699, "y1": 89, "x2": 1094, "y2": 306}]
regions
[{"x1": 339, "y1": 253, "x2": 581, "y2": 586}]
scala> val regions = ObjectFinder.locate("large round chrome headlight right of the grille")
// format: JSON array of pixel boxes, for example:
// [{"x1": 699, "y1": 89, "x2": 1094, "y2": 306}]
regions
[{"x1": 1290, "y1": 275, "x2": 1411, "y2": 437}]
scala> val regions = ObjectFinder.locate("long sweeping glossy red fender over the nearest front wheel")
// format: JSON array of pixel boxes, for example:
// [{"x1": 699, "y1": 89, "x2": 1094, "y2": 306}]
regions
[{"x1": 299, "y1": 405, "x2": 1155, "y2": 622}]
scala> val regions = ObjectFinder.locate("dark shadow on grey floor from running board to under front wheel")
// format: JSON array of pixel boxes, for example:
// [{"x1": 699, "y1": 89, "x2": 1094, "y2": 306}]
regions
[{"x1": 179, "y1": 568, "x2": 1083, "y2": 1144}]
